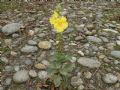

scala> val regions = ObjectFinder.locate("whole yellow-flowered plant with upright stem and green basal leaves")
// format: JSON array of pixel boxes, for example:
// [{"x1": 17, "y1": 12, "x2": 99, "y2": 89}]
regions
[{"x1": 48, "y1": 5, "x2": 74, "y2": 90}]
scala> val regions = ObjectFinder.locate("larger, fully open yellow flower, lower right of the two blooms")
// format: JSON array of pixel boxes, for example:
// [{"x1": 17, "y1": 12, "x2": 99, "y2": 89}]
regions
[{"x1": 54, "y1": 16, "x2": 68, "y2": 33}]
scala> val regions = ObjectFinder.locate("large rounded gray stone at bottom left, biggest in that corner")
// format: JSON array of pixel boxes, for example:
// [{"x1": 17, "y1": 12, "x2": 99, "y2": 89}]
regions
[{"x1": 13, "y1": 70, "x2": 29, "y2": 83}]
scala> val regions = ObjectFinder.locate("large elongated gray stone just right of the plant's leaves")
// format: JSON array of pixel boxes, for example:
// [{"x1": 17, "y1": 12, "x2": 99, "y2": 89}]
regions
[{"x1": 78, "y1": 57, "x2": 101, "y2": 68}]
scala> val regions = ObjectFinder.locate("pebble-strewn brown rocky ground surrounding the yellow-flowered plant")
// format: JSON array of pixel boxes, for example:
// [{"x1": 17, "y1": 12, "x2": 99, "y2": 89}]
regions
[{"x1": 0, "y1": 0, "x2": 120, "y2": 90}]
